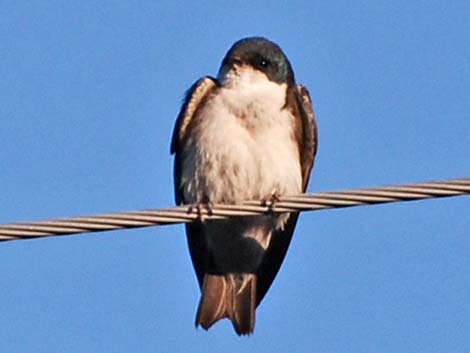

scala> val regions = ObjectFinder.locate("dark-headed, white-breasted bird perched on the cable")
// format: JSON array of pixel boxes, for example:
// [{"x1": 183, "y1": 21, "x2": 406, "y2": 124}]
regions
[{"x1": 171, "y1": 37, "x2": 317, "y2": 335}]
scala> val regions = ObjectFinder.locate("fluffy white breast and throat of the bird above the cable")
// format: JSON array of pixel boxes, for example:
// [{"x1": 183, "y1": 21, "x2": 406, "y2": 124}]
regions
[{"x1": 181, "y1": 66, "x2": 302, "y2": 203}]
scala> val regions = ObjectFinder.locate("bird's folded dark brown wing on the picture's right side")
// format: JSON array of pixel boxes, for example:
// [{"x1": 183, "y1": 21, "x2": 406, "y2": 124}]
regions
[{"x1": 256, "y1": 85, "x2": 318, "y2": 305}]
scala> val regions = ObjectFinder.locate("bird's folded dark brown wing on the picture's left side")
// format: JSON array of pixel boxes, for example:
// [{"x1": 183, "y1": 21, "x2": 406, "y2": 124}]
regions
[{"x1": 170, "y1": 77, "x2": 218, "y2": 287}]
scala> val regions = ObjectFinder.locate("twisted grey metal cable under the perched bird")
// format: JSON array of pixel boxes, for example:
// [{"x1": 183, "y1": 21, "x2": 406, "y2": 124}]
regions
[{"x1": 0, "y1": 178, "x2": 470, "y2": 241}]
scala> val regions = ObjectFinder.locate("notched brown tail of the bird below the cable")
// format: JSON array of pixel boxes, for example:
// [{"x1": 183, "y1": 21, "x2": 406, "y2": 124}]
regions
[{"x1": 196, "y1": 274, "x2": 256, "y2": 335}]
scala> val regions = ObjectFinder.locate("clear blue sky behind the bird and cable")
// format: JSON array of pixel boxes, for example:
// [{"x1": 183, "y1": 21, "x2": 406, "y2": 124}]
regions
[{"x1": 0, "y1": 0, "x2": 470, "y2": 353}]
